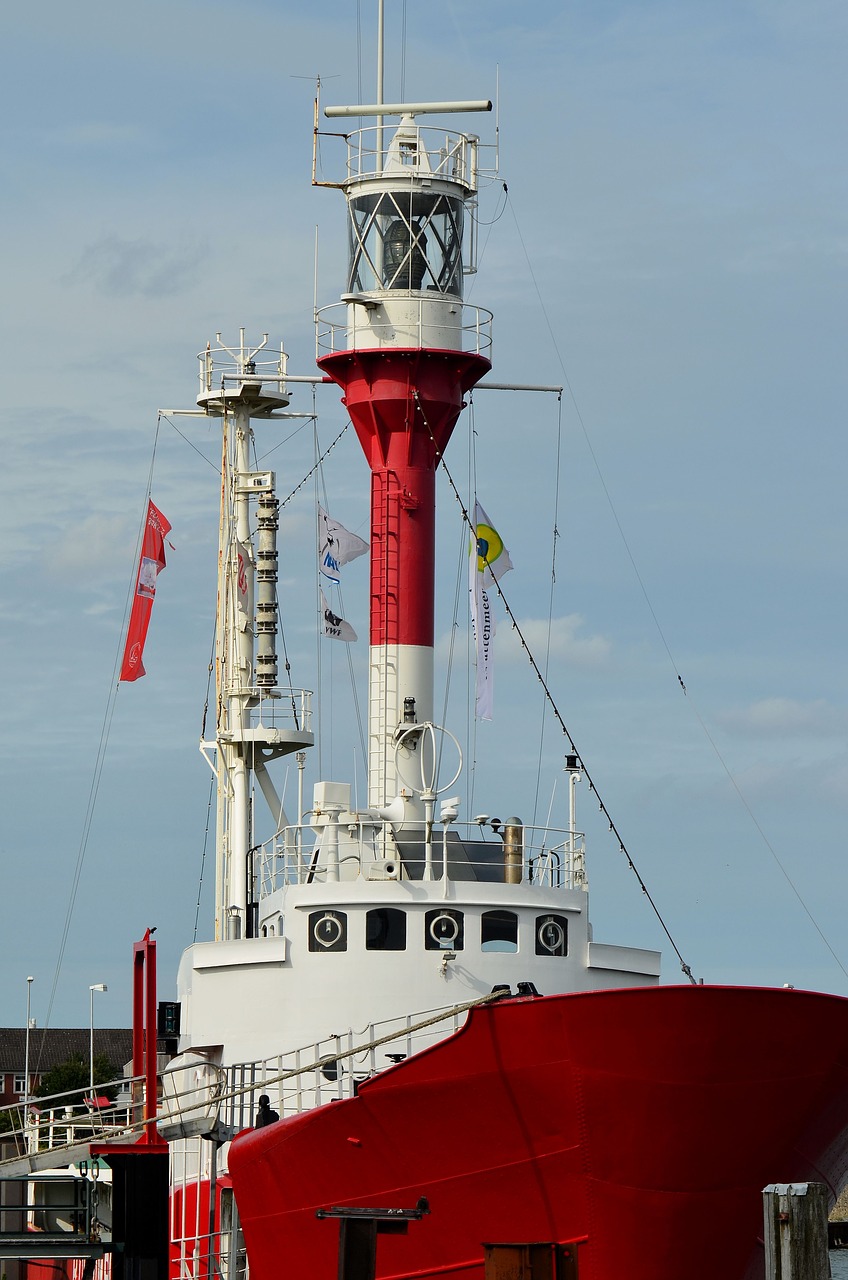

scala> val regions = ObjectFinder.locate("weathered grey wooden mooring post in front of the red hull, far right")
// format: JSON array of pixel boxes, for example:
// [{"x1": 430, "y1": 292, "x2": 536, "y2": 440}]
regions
[{"x1": 762, "y1": 1183, "x2": 830, "y2": 1280}]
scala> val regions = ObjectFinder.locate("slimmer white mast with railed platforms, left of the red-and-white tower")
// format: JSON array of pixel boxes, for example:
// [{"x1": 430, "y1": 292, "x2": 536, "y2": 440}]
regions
[{"x1": 197, "y1": 329, "x2": 313, "y2": 941}]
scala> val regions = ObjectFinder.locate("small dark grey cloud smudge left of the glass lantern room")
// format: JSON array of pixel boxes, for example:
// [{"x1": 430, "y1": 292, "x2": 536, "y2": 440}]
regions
[{"x1": 67, "y1": 236, "x2": 205, "y2": 298}]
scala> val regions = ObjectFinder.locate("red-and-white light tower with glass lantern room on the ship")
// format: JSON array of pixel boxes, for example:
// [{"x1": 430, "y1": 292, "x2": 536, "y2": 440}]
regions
[{"x1": 318, "y1": 102, "x2": 492, "y2": 817}]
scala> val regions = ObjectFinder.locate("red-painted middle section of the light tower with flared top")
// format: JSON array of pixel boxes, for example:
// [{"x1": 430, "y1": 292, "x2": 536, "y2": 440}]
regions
[{"x1": 318, "y1": 348, "x2": 491, "y2": 648}]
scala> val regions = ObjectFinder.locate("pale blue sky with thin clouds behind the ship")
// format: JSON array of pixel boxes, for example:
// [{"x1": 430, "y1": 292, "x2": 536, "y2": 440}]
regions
[{"x1": 0, "y1": 0, "x2": 848, "y2": 1027}]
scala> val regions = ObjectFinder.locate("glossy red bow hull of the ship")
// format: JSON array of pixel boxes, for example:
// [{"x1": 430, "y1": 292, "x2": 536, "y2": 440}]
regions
[{"x1": 229, "y1": 987, "x2": 848, "y2": 1280}]
